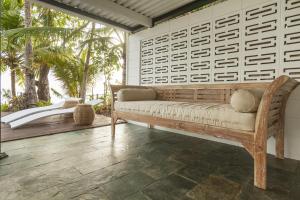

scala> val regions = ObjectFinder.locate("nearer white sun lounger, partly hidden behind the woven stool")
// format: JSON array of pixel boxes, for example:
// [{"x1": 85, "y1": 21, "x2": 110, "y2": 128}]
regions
[{"x1": 9, "y1": 100, "x2": 102, "y2": 129}]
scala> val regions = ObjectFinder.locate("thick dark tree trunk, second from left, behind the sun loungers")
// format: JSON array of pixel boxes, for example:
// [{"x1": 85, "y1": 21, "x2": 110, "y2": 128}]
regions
[{"x1": 37, "y1": 64, "x2": 50, "y2": 101}]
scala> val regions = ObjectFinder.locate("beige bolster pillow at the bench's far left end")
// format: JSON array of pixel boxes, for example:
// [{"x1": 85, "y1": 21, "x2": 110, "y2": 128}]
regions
[{"x1": 117, "y1": 88, "x2": 156, "y2": 101}]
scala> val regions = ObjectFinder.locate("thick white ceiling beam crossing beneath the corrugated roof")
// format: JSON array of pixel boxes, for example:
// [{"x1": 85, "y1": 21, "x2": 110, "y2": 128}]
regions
[{"x1": 80, "y1": 0, "x2": 152, "y2": 27}]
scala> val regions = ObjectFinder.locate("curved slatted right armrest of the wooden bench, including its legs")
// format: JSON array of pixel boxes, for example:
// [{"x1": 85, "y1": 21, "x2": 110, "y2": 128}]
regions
[{"x1": 252, "y1": 76, "x2": 299, "y2": 189}]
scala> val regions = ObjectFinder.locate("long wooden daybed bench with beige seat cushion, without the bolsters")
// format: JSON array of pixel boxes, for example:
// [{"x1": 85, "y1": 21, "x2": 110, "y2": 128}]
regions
[{"x1": 111, "y1": 76, "x2": 298, "y2": 189}]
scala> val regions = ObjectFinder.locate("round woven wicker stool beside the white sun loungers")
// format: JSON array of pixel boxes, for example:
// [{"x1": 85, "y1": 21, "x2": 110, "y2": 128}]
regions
[{"x1": 73, "y1": 104, "x2": 95, "y2": 126}]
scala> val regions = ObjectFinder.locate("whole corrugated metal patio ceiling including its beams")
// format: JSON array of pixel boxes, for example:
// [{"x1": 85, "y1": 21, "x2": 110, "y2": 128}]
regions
[{"x1": 35, "y1": 0, "x2": 213, "y2": 31}]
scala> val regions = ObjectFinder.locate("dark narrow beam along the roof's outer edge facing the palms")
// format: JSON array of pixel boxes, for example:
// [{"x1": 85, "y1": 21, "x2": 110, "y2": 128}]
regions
[{"x1": 31, "y1": 0, "x2": 133, "y2": 32}]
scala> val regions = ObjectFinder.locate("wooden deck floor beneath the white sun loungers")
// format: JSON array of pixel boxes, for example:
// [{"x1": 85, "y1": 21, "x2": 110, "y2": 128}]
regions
[{"x1": 1, "y1": 113, "x2": 123, "y2": 142}]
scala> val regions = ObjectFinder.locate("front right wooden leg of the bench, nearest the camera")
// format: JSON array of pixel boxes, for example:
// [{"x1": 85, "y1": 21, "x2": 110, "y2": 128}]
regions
[{"x1": 253, "y1": 146, "x2": 267, "y2": 190}]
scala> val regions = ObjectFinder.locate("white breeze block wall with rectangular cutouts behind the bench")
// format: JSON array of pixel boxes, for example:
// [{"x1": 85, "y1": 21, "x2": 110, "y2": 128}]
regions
[{"x1": 127, "y1": 0, "x2": 300, "y2": 160}]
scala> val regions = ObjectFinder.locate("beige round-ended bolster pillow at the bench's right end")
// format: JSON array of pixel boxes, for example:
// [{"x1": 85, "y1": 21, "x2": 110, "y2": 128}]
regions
[{"x1": 230, "y1": 89, "x2": 263, "y2": 113}]
